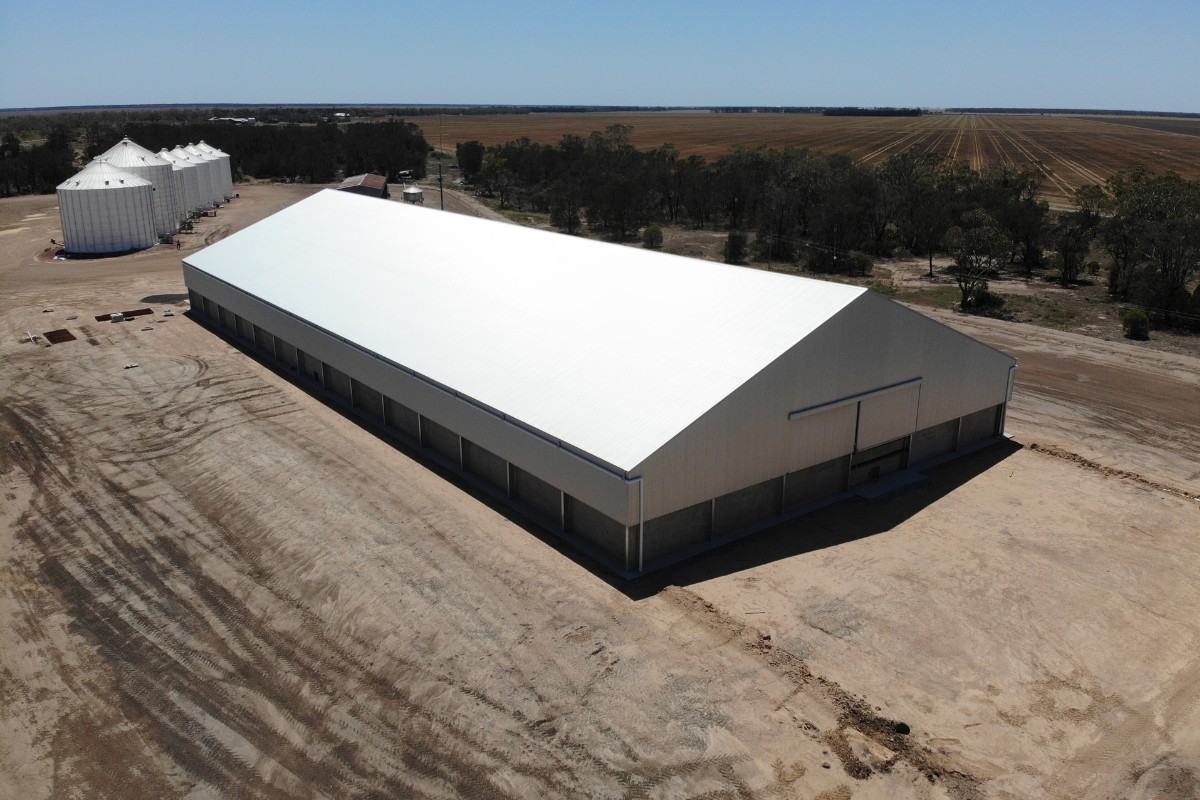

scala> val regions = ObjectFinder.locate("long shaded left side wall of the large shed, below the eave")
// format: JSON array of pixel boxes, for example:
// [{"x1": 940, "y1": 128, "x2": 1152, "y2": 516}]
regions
[{"x1": 184, "y1": 261, "x2": 640, "y2": 570}]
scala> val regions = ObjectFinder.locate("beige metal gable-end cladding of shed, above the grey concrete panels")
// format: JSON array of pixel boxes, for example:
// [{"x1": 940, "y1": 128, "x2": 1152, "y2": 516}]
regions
[{"x1": 632, "y1": 294, "x2": 1014, "y2": 519}]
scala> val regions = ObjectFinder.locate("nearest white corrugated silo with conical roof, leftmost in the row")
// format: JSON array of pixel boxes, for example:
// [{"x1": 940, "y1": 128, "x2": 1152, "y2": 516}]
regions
[{"x1": 58, "y1": 161, "x2": 158, "y2": 253}]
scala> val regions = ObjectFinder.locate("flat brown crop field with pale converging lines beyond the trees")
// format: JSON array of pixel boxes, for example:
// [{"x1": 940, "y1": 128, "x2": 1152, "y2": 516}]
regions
[{"x1": 429, "y1": 112, "x2": 1200, "y2": 206}]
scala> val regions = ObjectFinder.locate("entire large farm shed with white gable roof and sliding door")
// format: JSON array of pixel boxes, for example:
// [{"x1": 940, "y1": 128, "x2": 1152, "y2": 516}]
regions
[{"x1": 184, "y1": 191, "x2": 1016, "y2": 575}]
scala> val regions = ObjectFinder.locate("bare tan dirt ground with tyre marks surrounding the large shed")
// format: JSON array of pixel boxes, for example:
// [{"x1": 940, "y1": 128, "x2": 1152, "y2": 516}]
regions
[{"x1": 0, "y1": 186, "x2": 1200, "y2": 800}]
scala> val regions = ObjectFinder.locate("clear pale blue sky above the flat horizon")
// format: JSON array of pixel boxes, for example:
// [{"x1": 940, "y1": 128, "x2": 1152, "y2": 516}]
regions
[{"x1": 0, "y1": 0, "x2": 1200, "y2": 113}]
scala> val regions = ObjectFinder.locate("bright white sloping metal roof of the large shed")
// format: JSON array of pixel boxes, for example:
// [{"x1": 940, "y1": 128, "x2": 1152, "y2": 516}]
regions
[{"x1": 186, "y1": 190, "x2": 865, "y2": 470}]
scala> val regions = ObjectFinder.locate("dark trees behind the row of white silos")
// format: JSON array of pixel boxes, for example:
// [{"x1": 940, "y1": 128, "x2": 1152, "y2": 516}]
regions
[{"x1": 0, "y1": 114, "x2": 430, "y2": 197}]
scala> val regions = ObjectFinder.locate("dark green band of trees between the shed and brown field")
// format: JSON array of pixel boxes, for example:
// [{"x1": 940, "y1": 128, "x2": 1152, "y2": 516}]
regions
[{"x1": 456, "y1": 125, "x2": 1200, "y2": 327}]
